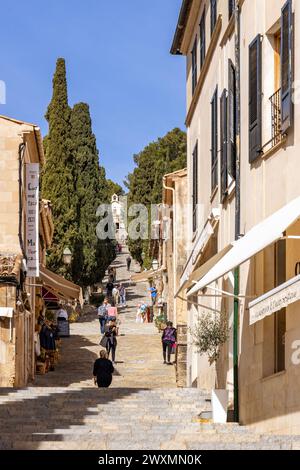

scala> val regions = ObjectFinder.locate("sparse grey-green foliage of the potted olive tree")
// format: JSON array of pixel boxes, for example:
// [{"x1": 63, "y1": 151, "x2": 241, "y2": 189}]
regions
[{"x1": 191, "y1": 313, "x2": 229, "y2": 364}]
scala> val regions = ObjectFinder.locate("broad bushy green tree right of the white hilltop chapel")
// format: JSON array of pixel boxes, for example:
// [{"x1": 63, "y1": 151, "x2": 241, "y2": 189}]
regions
[{"x1": 125, "y1": 128, "x2": 186, "y2": 267}]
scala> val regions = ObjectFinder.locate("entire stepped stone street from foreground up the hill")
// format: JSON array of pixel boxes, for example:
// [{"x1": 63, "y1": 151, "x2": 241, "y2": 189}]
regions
[{"x1": 0, "y1": 253, "x2": 300, "y2": 450}]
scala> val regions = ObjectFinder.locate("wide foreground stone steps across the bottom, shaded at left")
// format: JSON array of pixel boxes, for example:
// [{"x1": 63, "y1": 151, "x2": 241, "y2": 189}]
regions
[{"x1": 0, "y1": 386, "x2": 300, "y2": 450}]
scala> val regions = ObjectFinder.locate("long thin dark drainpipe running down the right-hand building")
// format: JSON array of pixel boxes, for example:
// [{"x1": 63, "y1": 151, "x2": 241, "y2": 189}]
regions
[{"x1": 233, "y1": 2, "x2": 241, "y2": 422}]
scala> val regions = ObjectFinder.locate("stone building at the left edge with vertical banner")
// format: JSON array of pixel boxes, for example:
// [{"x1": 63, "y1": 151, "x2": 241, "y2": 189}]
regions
[{"x1": 0, "y1": 116, "x2": 45, "y2": 387}]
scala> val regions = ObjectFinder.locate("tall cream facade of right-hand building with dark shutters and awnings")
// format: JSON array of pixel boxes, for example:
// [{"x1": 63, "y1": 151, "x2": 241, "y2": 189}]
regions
[{"x1": 171, "y1": 0, "x2": 300, "y2": 433}]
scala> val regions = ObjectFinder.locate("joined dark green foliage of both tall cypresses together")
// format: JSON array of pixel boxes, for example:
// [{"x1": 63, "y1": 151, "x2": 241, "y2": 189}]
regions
[{"x1": 42, "y1": 59, "x2": 115, "y2": 287}]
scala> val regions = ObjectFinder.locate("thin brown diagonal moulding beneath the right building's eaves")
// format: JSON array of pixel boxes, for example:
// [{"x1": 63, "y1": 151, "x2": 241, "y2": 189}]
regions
[{"x1": 185, "y1": 15, "x2": 222, "y2": 127}]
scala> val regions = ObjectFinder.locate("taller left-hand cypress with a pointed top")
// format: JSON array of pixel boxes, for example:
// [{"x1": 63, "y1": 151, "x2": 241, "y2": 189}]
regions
[{"x1": 42, "y1": 58, "x2": 78, "y2": 277}]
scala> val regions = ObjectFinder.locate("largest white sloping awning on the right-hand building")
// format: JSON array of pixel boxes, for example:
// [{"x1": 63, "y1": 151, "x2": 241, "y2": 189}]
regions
[{"x1": 188, "y1": 197, "x2": 300, "y2": 296}]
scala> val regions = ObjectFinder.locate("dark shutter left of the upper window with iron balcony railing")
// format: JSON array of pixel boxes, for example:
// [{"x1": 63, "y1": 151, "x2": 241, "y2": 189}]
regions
[{"x1": 249, "y1": 35, "x2": 262, "y2": 163}]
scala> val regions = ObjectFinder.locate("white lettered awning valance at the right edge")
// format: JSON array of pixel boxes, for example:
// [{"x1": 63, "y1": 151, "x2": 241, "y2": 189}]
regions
[{"x1": 249, "y1": 276, "x2": 300, "y2": 325}]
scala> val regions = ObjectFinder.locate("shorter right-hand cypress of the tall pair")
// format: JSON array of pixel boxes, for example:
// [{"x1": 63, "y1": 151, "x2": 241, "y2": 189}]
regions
[{"x1": 71, "y1": 103, "x2": 115, "y2": 286}]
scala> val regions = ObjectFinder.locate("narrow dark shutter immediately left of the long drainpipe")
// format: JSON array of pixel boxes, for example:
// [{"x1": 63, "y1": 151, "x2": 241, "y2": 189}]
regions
[{"x1": 227, "y1": 59, "x2": 236, "y2": 179}]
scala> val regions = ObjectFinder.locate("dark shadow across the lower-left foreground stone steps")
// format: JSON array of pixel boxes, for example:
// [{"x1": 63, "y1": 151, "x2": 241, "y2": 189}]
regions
[{"x1": 0, "y1": 387, "x2": 147, "y2": 450}]
